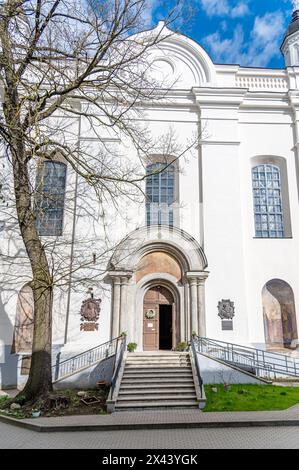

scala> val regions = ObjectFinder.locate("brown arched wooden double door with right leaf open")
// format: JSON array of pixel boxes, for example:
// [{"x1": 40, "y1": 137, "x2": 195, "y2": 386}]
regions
[{"x1": 143, "y1": 286, "x2": 175, "y2": 351}]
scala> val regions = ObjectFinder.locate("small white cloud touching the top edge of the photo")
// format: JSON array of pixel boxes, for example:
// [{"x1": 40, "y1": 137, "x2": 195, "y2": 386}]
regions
[{"x1": 201, "y1": 0, "x2": 249, "y2": 18}]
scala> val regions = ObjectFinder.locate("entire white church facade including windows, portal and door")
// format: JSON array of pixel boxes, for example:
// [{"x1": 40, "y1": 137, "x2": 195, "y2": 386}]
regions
[{"x1": 0, "y1": 11, "x2": 299, "y2": 388}]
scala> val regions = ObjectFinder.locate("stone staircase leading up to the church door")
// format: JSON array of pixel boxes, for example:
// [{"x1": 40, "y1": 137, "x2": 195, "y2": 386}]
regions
[{"x1": 115, "y1": 351, "x2": 199, "y2": 411}]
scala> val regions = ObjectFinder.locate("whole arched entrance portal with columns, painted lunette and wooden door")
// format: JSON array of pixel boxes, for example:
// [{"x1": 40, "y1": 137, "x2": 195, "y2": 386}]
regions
[{"x1": 106, "y1": 225, "x2": 209, "y2": 351}]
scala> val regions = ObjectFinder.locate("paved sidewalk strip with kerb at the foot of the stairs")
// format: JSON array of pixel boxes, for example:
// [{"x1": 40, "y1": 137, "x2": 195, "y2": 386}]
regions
[{"x1": 0, "y1": 404, "x2": 299, "y2": 434}]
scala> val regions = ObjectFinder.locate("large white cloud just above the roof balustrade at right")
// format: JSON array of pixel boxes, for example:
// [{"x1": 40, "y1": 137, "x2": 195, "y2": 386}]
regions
[{"x1": 203, "y1": 11, "x2": 285, "y2": 67}]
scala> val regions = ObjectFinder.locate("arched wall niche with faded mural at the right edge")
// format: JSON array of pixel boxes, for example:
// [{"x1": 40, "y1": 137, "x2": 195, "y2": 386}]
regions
[{"x1": 262, "y1": 279, "x2": 298, "y2": 348}]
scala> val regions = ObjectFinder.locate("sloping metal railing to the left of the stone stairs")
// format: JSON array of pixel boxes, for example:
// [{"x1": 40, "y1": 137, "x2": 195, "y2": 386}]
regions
[{"x1": 52, "y1": 337, "x2": 119, "y2": 382}]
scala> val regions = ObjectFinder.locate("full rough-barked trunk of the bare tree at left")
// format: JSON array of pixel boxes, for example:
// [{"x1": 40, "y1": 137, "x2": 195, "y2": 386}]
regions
[{"x1": 0, "y1": 15, "x2": 53, "y2": 401}]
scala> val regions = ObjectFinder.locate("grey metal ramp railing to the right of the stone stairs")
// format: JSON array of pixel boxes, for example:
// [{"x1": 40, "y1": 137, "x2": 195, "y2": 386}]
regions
[{"x1": 195, "y1": 337, "x2": 299, "y2": 378}]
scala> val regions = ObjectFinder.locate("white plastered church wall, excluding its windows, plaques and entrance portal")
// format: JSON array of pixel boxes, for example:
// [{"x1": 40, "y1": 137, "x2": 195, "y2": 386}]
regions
[{"x1": 0, "y1": 29, "x2": 299, "y2": 386}]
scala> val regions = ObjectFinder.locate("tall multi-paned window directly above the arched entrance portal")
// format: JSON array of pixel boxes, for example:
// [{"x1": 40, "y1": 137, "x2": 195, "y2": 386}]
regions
[{"x1": 146, "y1": 163, "x2": 175, "y2": 226}]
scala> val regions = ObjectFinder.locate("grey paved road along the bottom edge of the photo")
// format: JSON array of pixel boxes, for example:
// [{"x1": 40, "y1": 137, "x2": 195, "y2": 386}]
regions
[{"x1": 0, "y1": 423, "x2": 299, "y2": 449}]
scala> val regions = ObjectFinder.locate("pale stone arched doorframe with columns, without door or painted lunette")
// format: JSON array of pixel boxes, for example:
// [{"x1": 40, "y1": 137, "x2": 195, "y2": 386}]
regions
[{"x1": 106, "y1": 226, "x2": 209, "y2": 350}]
